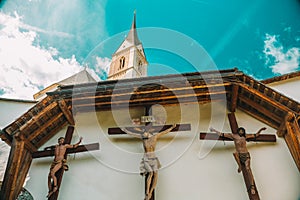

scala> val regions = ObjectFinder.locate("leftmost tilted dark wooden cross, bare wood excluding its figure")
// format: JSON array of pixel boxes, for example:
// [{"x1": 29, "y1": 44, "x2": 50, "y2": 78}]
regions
[{"x1": 32, "y1": 126, "x2": 100, "y2": 200}]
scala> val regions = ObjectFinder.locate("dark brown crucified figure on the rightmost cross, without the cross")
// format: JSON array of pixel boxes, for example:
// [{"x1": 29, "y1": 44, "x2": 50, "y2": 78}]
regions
[{"x1": 210, "y1": 127, "x2": 266, "y2": 194}]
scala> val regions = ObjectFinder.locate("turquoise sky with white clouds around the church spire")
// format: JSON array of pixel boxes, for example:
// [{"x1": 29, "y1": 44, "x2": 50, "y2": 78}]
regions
[{"x1": 0, "y1": 0, "x2": 300, "y2": 99}]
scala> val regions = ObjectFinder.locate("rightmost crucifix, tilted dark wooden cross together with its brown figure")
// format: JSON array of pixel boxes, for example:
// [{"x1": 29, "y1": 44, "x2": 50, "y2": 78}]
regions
[{"x1": 200, "y1": 113, "x2": 276, "y2": 200}]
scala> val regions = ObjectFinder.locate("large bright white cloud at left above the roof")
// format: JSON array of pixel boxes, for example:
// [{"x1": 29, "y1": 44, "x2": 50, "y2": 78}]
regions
[{"x1": 0, "y1": 13, "x2": 105, "y2": 99}]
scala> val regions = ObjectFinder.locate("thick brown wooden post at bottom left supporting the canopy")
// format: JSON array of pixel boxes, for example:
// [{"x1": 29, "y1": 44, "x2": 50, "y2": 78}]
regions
[{"x1": 0, "y1": 139, "x2": 32, "y2": 200}]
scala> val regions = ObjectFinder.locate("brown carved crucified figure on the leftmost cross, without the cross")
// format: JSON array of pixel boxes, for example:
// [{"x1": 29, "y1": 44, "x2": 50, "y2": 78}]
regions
[{"x1": 45, "y1": 137, "x2": 82, "y2": 197}]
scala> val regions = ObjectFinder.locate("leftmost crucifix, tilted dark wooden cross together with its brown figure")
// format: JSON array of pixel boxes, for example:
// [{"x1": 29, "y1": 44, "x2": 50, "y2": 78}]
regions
[{"x1": 32, "y1": 126, "x2": 99, "y2": 200}]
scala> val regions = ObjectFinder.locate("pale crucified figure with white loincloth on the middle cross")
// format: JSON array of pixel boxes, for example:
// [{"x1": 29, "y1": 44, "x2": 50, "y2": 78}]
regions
[{"x1": 121, "y1": 124, "x2": 176, "y2": 200}]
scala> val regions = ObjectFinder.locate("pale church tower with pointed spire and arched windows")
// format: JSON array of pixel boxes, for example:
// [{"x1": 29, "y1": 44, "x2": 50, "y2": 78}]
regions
[{"x1": 108, "y1": 12, "x2": 148, "y2": 80}]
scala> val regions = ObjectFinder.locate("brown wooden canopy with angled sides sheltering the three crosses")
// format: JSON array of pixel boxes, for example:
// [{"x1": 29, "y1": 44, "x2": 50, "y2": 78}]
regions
[{"x1": 0, "y1": 69, "x2": 300, "y2": 199}]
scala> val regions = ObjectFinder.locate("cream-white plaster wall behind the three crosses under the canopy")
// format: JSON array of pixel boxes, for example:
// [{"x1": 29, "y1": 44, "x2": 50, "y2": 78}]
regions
[{"x1": 26, "y1": 96, "x2": 300, "y2": 200}]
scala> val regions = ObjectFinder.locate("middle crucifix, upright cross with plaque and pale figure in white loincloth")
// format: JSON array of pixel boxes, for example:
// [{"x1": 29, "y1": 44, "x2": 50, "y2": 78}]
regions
[{"x1": 108, "y1": 107, "x2": 191, "y2": 200}]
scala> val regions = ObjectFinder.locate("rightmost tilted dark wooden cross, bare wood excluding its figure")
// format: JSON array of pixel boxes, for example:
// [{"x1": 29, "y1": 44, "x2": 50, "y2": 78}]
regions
[{"x1": 200, "y1": 113, "x2": 276, "y2": 200}]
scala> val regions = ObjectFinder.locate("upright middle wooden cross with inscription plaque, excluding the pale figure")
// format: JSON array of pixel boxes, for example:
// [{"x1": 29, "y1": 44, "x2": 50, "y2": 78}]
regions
[{"x1": 108, "y1": 106, "x2": 191, "y2": 200}]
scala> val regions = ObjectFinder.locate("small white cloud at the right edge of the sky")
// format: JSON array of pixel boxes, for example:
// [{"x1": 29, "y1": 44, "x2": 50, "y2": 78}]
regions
[{"x1": 264, "y1": 34, "x2": 300, "y2": 74}]
